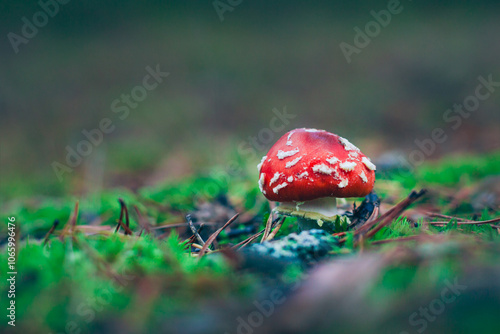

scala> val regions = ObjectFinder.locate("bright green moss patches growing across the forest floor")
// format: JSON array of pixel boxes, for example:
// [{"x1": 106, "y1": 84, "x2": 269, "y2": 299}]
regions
[{"x1": 0, "y1": 154, "x2": 500, "y2": 332}]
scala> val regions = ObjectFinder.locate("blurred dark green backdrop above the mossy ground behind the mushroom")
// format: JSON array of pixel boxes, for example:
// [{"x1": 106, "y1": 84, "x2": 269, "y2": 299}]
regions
[{"x1": 0, "y1": 0, "x2": 500, "y2": 199}]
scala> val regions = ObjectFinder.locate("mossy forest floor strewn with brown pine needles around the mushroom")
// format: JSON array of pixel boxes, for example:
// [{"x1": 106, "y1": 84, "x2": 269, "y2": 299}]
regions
[{"x1": 0, "y1": 153, "x2": 500, "y2": 334}]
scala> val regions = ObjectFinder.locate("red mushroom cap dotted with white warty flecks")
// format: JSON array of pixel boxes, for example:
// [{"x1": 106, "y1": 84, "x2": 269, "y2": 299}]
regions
[{"x1": 257, "y1": 129, "x2": 376, "y2": 202}]
